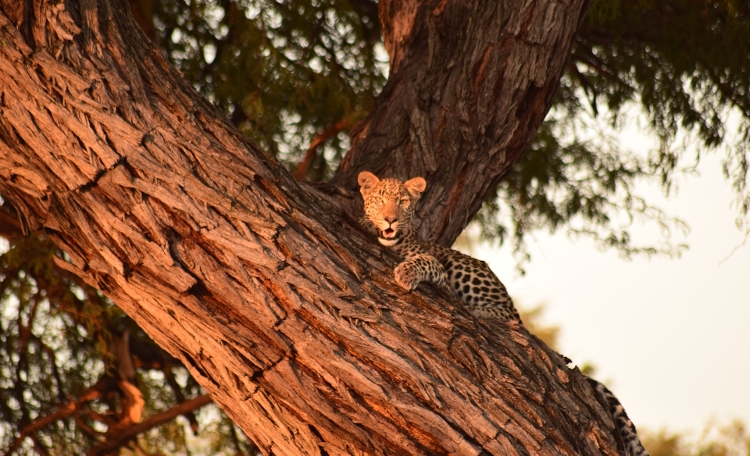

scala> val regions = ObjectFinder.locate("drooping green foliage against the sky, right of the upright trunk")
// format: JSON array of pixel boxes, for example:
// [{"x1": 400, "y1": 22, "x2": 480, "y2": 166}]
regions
[{"x1": 478, "y1": 0, "x2": 750, "y2": 264}]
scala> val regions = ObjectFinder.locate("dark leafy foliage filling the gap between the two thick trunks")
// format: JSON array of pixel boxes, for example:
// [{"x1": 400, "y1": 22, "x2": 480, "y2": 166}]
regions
[{"x1": 145, "y1": 0, "x2": 386, "y2": 180}]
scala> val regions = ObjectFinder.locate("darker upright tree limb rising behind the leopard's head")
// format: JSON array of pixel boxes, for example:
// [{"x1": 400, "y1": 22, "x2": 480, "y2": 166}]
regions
[{"x1": 334, "y1": 0, "x2": 590, "y2": 246}]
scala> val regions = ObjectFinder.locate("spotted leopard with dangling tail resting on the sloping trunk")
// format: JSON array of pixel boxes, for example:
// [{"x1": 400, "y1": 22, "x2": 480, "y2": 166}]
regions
[{"x1": 357, "y1": 171, "x2": 649, "y2": 456}]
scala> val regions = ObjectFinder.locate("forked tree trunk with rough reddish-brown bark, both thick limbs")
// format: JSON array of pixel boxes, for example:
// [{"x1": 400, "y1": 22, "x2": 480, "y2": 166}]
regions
[{"x1": 0, "y1": 0, "x2": 622, "y2": 455}]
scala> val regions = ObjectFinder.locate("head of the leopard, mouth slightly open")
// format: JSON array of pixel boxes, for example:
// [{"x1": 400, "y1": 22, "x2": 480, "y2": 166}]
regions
[{"x1": 357, "y1": 171, "x2": 427, "y2": 246}]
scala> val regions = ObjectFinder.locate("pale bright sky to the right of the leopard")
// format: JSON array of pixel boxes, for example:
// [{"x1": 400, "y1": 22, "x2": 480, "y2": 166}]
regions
[{"x1": 471, "y1": 129, "x2": 750, "y2": 432}]
